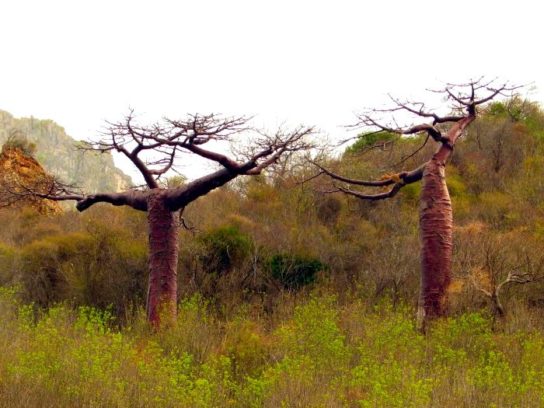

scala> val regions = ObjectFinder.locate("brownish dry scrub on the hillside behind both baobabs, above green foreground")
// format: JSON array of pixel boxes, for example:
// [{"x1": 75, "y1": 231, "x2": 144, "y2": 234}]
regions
[{"x1": 0, "y1": 100, "x2": 544, "y2": 315}]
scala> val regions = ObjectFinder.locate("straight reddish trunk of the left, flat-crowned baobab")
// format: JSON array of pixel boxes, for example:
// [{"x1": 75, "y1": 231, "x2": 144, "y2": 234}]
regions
[{"x1": 147, "y1": 191, "x2": 178, "y2": 327}]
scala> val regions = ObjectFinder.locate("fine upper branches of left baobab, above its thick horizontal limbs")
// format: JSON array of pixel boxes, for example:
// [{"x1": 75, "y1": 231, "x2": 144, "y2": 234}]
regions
[{"x1": 90, "y1": 112, "x2": 312, "y2": 189}]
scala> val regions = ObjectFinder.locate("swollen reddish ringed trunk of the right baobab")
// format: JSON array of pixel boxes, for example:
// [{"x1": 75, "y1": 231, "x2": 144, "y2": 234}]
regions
[{"x1": 418, "y1": 155, "x2": 453, "y2": 328}]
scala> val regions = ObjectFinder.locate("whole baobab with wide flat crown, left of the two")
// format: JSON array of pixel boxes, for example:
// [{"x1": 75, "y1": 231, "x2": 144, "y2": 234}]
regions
[{"x1": 7, "y1": 112, "x2": 313, "y2": 327}]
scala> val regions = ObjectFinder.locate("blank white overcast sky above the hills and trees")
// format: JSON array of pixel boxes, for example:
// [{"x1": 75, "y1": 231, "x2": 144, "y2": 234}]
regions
[{"x1": 0, "y1": 0, "x2": 544, "y2": 182}]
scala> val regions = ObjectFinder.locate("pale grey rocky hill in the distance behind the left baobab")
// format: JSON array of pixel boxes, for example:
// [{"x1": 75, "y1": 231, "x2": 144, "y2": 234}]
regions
[{"x1": 0, "y1": 110, "x2": 131, "y2": 193}]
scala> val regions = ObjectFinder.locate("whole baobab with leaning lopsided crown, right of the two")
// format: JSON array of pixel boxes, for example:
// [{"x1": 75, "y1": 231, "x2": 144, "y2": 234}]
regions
[{"x1": 314, "y1": 79, "x2": 516, "y2": 328}]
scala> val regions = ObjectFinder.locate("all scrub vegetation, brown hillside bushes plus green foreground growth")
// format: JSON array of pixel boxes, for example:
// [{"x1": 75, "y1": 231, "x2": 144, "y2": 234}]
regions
[{"x1": 0, "y1": 100, "x2": 544, "y2": 407}]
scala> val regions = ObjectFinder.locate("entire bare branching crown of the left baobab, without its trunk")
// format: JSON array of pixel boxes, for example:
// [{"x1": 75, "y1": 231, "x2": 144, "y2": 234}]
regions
[{"x1": 5, "y1": 111, "x2": 314, "y2": 211}]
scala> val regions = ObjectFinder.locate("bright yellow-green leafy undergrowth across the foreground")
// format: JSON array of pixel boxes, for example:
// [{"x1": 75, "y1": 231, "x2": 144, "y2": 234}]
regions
[{"x1": 0, "y1": 289, "x2": 544, "y2": 407}]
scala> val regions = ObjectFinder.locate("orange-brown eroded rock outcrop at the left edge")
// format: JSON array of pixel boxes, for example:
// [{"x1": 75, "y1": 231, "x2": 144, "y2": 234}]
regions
[{"x1": 0, "y1": 146, "x2": 62, "y2": 214}]
